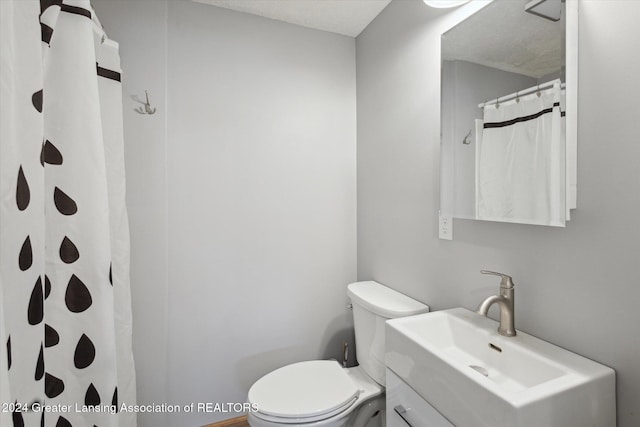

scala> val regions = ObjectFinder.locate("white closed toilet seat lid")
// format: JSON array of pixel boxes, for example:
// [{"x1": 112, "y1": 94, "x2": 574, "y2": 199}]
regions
[{"x1": 248, "y1": 360, "x2": 360, "y2": 424}]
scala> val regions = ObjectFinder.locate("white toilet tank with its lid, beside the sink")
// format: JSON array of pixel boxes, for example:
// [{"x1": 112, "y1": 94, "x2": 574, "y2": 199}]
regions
[{"x1": 347, "y1": 281, "x2": 429, "y2": 385}]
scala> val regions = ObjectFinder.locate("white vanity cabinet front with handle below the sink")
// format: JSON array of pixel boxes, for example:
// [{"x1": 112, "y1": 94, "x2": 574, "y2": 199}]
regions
[{"x1": 386, "y1": 368, "x2": 455, "y2": 427}]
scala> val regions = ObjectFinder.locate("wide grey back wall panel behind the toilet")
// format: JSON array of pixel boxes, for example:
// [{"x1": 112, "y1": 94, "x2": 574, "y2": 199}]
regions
[{"x1": 167, "y1": 2, "x2": 356, "y2": 426}]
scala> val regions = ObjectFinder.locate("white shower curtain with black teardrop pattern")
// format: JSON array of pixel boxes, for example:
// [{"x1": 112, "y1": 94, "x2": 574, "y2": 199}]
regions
[{"x1": 0, "y1": 0, "x2": 136, "y2": 427}]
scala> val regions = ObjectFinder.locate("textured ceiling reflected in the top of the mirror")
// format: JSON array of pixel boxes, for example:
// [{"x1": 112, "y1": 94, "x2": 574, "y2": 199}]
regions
[{"x1": 442, "y1": 0, "x2": 565, "y2": 78}]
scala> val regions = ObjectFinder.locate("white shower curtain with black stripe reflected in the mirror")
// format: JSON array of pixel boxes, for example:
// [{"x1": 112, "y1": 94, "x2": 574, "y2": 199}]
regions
[{"x1": 476, "y1": 80, "x2": 566, "y2": 227}]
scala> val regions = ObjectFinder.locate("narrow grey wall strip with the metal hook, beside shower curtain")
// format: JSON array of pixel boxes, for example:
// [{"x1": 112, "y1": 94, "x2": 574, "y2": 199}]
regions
[{"x1": 92, "y1": 0, "x2": 168, "y2": 427}]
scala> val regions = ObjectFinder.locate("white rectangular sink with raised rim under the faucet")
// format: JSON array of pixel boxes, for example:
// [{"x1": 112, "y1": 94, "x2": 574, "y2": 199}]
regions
[{"x1": 386, "y1": 308, "x2": 616, "y2": 427}]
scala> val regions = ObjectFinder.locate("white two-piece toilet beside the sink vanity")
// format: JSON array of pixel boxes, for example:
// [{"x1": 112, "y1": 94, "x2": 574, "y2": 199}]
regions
[{"x1": 248, "y1": 281, "x2": 429, "y2": 427}]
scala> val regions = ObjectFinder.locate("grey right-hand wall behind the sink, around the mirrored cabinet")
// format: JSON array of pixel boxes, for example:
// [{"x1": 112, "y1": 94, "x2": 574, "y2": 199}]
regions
[{"x1": 356, "y1": 0, "x2": 640, "y2": 427}]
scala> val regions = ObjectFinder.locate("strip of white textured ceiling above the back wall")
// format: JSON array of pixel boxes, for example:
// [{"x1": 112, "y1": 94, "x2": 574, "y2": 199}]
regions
[{"x1": 193, "y1": 0, "x2": 391, "y2": 37}]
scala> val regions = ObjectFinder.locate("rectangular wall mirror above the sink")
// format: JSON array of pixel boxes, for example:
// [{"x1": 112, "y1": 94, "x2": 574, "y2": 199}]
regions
[{"x1": 440, "y1": 0, "x2": 578, "y2": 227}]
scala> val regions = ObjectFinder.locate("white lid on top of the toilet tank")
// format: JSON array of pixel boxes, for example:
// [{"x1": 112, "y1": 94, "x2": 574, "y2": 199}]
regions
[{"x1": 347, "y1": 280, "x2": 429, "y2": 319}]
